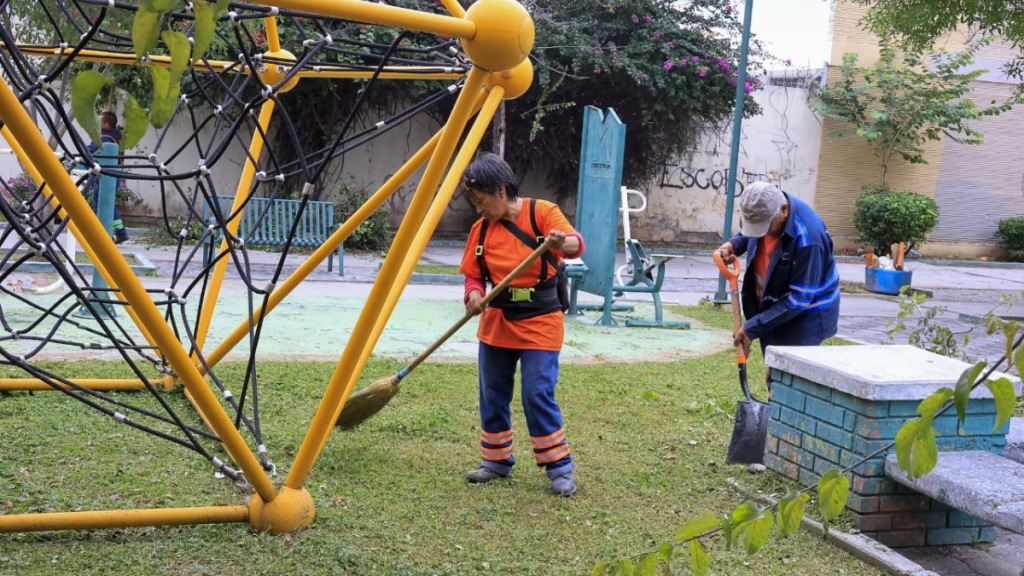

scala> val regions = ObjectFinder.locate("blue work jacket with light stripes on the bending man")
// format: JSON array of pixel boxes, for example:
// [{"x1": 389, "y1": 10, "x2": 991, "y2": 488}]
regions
[{"x1": 729, "y1": 195, "x2": 839, "y2": 351}]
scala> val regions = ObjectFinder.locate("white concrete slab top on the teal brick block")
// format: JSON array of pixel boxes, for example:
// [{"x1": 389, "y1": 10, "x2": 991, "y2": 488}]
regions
[{"x1": 765, "y1": 345, "x2": 1021, "y2": 401}]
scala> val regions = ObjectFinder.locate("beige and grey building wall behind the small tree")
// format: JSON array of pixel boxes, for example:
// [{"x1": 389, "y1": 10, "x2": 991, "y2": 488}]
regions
[{"x1": 815, "y1": 0, "x2": 1024, "y2": 256}]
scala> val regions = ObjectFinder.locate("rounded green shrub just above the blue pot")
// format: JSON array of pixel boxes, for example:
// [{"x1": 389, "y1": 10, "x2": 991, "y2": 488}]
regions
[{"x1": 852, "y1": 184, "x2": 939, "y2": 256}]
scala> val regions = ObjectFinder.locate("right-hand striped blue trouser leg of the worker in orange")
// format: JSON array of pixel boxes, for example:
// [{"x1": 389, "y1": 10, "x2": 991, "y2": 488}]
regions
[{"x1": 521, "y1": 351, "x2": 572, "y2": 476}]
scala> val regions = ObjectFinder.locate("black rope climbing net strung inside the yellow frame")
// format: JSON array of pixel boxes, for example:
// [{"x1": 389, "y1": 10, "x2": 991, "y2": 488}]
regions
[{"x1": 0, "y1": 0, "x2": 470, "y2": 485}]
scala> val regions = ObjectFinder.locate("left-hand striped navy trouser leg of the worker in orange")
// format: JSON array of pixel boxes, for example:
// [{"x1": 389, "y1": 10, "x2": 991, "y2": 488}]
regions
[{"x1": 479, "y1": 342, "x2": 519, "y2": 476}]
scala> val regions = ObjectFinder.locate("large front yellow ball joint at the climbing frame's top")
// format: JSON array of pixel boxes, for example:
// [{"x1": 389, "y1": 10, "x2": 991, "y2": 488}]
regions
[{"x1": 462, "y1": 0, "x2": 535, "y2": 72}]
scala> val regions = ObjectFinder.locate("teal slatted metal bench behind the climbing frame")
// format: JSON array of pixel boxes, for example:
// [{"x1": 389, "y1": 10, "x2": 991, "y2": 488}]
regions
[{"x1": 203, "y1": 196, "x2": 344, "y2": 276}]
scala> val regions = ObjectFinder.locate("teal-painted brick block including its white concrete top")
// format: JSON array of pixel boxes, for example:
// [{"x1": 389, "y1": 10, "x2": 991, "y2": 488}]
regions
[{"x1": 765, "y1": 346, "x2": 1019, "y2": 547}]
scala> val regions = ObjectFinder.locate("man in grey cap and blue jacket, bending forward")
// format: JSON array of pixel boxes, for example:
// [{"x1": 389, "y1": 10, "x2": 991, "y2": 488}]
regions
[{"x1": 719, "y1": 182, "x2": 839, "y2": 366}]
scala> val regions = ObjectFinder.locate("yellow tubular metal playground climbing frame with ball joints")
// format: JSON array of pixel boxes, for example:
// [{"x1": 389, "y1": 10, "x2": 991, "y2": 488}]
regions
[{"x1": 0, "y1": 0, "x2": 534, "y2": 533}]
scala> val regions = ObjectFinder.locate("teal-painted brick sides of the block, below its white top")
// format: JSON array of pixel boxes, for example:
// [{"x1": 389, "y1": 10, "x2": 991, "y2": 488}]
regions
[{"x1": 765, "y1": 370, "x2": 1008, "y2": 546}]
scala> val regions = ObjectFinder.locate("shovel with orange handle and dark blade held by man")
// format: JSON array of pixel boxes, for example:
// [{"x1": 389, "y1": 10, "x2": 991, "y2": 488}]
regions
[{"x1": 715, "y1": 250, "x2": 768, "y2": 464}]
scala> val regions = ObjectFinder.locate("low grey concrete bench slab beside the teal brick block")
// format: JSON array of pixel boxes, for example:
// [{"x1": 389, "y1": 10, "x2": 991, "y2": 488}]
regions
[{"x1": 886, "y1": 450, "x2": 1024, "y2": 534}]
